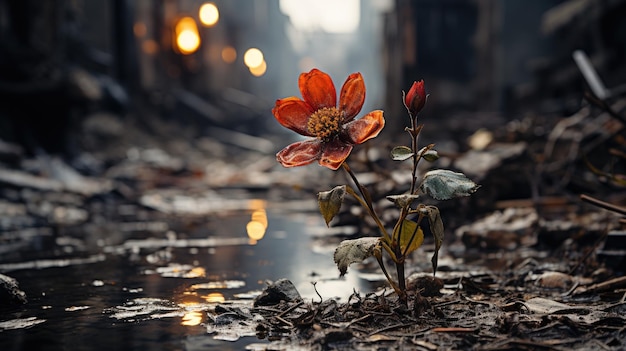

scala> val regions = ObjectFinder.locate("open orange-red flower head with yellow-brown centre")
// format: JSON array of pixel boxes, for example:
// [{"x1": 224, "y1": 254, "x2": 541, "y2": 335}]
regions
[{"x1": 272, "y1": 69, "x2": 385, "y2": 170}]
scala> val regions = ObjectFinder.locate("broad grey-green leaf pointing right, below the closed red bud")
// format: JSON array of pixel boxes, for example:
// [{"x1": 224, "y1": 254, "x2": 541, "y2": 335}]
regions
[{"x1": 420, "y1": 169, "x2": 480, "y2": 200}]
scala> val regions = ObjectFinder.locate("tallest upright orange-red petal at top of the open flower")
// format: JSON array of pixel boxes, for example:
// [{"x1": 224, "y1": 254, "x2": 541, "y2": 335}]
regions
[{"x1": 298, "y1": 68, "x2": 337, "y2": 110}]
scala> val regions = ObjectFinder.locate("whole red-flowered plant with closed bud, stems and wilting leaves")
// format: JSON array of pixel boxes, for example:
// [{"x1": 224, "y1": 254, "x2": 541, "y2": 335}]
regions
[{"x1": 272, "y1": 69, "x2": 478, "y2": 307}]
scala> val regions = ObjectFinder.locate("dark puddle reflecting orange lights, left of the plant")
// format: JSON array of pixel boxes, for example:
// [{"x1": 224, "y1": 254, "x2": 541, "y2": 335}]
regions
[{"x1": 0, "y1": 202, "x2": 366, "y2": 350}]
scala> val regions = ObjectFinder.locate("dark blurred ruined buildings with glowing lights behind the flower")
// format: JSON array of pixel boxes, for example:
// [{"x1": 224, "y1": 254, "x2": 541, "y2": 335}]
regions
[{"x1": 0, "y1": 0, "x2": 626, "y2": 157}]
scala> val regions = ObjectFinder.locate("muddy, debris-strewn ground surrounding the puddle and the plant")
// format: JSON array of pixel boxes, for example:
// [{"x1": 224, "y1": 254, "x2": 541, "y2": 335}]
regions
[{"x1": 0, "y1": 96, "x2": 626, "y2": 350}]
